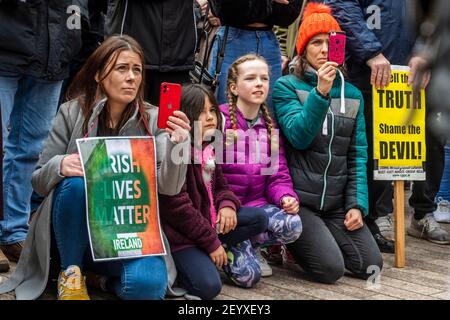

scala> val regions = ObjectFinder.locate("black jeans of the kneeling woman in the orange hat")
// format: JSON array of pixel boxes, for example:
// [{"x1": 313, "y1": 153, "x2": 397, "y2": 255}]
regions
[{"x1": 286, "y1": 207, "x2": 383, "y2": 283}]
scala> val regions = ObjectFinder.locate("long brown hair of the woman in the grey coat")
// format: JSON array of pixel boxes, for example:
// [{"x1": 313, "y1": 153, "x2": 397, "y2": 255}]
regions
[{"x1": 66, "y1": 35, "x2": 148, "y2": 133}]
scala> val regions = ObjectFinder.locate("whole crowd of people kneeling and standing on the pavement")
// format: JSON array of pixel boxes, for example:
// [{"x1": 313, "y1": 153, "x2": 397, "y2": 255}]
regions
[{"x1": 0, "y1": 0, "x2": 450, "y2": 300}]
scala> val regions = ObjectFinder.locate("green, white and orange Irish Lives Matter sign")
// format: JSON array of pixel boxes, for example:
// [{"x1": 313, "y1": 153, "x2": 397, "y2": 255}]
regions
[{"x1": 77, "y1": 137, "x2": 165, "y2": 261}]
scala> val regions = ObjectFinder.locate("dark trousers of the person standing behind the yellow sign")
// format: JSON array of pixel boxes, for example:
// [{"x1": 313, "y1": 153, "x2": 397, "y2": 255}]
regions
[{"x1": 362, "y1": 91, "x2": 446, "y2": 225}]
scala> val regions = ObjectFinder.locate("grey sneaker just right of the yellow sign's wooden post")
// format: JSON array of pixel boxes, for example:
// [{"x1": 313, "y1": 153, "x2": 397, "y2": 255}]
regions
[{"x1": 407, "y1": 213, "x2": 450, "y2": 244}]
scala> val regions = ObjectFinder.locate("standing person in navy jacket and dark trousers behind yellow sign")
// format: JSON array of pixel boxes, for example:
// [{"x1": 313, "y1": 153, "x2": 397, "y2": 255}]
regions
[{"x1": 324, "y1": 0, "x2": 450, "y2": 253}]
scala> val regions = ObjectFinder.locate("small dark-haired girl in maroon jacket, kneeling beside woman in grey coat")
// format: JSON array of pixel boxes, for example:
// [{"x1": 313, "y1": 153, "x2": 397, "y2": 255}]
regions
[{"x1": 159, "y1": 85, "x2": 268, "y2": 299}]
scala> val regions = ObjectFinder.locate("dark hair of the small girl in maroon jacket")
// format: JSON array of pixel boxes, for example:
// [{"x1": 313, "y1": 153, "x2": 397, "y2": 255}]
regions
[{"x1": 180, "y1": 84, "x2": 222, "y2": 141}]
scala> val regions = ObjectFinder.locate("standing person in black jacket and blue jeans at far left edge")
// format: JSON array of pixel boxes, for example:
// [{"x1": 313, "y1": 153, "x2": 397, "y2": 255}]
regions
[{"x1": 0, "y1": 0, "x2": 87, "y2": 271}]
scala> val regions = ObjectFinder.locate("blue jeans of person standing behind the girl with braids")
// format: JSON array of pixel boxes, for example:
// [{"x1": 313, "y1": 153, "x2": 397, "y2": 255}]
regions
[{"x1": 210, "y1": 27, "x2": 281, "y2": 110}]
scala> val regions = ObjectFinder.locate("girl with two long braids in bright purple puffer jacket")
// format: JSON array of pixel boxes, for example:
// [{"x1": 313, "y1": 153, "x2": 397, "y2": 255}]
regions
[{"x1": 220, "y1": 54, "x2": 302, "y2": 276}]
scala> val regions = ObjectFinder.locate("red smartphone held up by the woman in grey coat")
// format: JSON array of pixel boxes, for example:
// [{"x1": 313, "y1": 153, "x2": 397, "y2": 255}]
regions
[{"x1": 158, "y1": 82, "x2": 181, "y2": 129}]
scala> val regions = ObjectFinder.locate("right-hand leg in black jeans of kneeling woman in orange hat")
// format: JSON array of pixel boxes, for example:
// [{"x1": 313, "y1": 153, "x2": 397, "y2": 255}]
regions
[{"x1": 323, "y1": 213, "x2": 383, "y2": 279}]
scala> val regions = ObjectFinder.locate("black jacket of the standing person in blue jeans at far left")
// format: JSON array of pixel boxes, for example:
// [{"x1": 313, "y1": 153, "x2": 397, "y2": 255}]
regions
[{"x1": 0, "y1": 0, "x2": 88, "y2": 80}]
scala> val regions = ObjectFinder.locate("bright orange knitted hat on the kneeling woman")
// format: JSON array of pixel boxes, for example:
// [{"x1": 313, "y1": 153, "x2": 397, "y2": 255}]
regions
[{"x1": 296, "y1": 2, "x2": 341, "y2": 55}]
